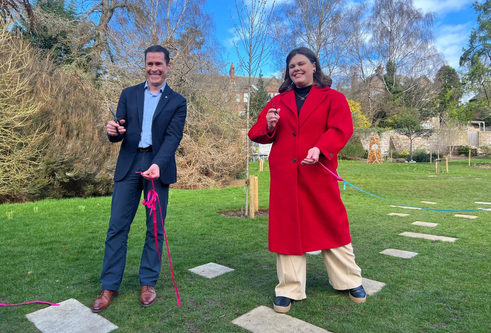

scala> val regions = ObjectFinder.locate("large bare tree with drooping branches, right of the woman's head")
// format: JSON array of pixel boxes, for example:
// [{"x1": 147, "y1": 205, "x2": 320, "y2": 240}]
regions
[{"x1": 350, "y1": 0, "x2": 443, "y2": 121}]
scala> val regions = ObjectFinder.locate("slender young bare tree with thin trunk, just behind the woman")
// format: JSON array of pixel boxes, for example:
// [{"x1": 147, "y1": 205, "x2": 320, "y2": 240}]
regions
[{"x1": 232, "y1": 0, "x2": 275, "y2": 216}]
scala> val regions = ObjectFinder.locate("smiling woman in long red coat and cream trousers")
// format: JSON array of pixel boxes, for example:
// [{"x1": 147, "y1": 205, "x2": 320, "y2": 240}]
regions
[{"x1": 249, "y1": 47, "x2": 366, "y2": 313}]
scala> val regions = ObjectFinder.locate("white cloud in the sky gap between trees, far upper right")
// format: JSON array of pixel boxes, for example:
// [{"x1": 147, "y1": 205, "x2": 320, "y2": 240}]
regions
[{"x1": 436, "y1": 22, "x2": 473, "y2": 69}]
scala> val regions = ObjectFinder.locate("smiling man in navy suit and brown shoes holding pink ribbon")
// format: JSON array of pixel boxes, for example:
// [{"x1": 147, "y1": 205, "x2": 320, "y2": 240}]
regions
[{"x1": 92, "y1": 45, "x2": 187, "y2": 312}]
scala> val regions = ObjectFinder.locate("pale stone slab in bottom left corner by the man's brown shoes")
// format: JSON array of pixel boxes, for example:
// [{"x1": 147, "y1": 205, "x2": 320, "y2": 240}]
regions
[{"x1": 26, "y1": 298, "x2": 118, "y2": 333}]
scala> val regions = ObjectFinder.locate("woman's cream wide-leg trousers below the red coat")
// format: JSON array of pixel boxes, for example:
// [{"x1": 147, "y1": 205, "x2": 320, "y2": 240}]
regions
[{"x1": 275, "y1": 243, "x2": 361, "y2": 301}]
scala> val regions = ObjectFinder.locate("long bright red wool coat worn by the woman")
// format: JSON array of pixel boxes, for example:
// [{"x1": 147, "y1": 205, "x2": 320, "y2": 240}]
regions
[{"x1": 249, "y1": 85, "x2": 353, "y2": 255}]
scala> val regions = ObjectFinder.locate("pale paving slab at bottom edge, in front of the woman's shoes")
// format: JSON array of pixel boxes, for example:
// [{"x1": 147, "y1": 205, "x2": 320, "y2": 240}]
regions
[{"x1": 232, "y1": 305, "x2": 332, "y2": 333}]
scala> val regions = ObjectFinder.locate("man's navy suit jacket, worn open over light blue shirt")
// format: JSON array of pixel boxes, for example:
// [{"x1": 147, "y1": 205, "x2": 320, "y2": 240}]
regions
[{"x1": 108, "y1": 83, "x2": 187, "y2": 184}]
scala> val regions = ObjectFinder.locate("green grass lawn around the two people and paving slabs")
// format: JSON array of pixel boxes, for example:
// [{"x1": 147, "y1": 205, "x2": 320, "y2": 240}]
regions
[{"x1": 0, "y1": 160, "x2": 491, "y2": 333}]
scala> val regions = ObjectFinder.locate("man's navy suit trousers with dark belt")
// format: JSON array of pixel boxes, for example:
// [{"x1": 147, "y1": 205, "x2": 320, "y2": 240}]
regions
[{"x1": 100, "y1": 152, "x2": 169, "y2": 290}]
